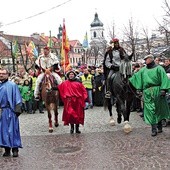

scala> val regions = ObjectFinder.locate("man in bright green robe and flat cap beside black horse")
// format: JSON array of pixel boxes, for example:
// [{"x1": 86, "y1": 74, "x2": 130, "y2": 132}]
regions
[{"x1": 129, "y1": 55, "x2": 170, "y2": 136}]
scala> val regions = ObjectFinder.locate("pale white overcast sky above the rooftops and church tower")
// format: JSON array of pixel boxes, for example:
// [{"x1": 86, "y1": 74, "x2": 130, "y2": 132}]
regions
[{"x1": 0, "y1": 0, "x2": 164, "y2": 42}]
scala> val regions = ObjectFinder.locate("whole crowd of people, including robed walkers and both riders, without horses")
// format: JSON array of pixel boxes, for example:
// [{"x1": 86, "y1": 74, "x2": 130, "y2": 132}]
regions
[{"x1": 0, "y1": 39, "x2": 170, "y2": 157}]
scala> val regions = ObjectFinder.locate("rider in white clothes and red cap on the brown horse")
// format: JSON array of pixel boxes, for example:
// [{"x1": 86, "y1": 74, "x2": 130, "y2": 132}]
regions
[{"x1": 34, "y1": 47, "x2": 62, "y2": 100}]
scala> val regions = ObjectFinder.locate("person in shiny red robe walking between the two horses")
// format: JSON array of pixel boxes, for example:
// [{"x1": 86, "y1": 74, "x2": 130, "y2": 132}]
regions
[{"x1": 58, "y1": 70, "x2": 87, "y2": 134}]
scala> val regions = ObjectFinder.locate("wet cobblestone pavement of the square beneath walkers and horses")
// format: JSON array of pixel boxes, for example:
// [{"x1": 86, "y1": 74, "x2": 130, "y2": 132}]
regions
[{"x1": 0, "y1": 107, "x2": 170, "y2": 170}]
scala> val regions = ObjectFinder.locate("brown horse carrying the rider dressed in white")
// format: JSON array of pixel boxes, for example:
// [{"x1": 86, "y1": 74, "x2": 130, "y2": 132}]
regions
[{"x1": 41, "y1": 73, "x2": 59, "y2": 133}]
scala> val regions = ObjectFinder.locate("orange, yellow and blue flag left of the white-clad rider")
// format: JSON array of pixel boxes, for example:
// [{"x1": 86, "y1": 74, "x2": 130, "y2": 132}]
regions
[{"x1": 25, "y1": 41, "x2": 38, "y2": 59}]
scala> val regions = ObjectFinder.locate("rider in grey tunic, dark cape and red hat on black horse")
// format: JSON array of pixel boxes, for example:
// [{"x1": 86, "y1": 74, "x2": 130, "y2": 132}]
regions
[{"x1": 104, "y1": 38, "x2": 126, "y2": 98}]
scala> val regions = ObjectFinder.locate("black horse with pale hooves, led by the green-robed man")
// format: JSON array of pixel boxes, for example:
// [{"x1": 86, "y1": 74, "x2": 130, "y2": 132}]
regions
[{"x1": 104, "y1": 53, "x2": 136, "y2": 133}]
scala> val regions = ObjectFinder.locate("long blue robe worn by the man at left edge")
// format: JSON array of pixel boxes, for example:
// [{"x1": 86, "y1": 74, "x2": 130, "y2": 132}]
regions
[{"x1": 0, "y1": 81, "x2": 22, "y2": 148}]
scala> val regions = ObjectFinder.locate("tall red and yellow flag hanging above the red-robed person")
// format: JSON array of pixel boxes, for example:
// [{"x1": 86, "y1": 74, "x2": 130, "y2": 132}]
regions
[{"x1": 61, "y1": 20, "x2": 71, "y2": 73}]
